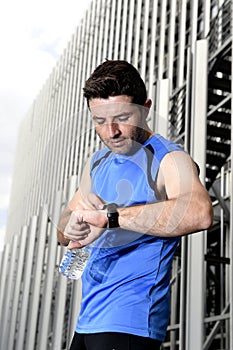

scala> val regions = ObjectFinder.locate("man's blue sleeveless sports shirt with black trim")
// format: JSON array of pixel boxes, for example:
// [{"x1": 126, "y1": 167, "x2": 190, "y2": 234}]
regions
[{"x1": 76, "y1": 135, "x2": 182, "y2": 341}]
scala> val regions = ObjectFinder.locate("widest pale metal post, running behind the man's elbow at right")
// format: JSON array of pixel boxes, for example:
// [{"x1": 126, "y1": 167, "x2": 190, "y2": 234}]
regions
[{"x1": 186, "y1": 40, "x2": 208, "y2": 350}]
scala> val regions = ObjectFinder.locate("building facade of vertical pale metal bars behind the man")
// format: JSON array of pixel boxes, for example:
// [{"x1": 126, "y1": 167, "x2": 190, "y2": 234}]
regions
[{"x1": 0, "y1": 0, "x2": 233, "y2": 350}]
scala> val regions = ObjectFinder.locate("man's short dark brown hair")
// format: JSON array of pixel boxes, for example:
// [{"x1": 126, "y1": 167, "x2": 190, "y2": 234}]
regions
[{"x1": 83, "y1": 60, "x2": 147, "y2": 105}]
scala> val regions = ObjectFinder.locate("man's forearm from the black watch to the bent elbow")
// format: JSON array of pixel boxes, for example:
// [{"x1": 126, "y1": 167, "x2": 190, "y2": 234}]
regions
[{"x1": 119, "y1": 193, "x2": 212, "y2": 237}]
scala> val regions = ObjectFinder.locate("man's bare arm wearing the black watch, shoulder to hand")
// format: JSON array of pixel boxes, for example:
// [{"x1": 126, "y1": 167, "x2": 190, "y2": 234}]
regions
[{"x1": 78, "y1": 151, "x2": 213, "y2": 237}]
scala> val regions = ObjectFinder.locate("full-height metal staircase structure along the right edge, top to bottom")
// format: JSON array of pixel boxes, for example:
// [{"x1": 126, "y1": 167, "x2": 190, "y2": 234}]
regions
[{"x1": 203, "y1": 1, "x2": 232, "y2": 350}]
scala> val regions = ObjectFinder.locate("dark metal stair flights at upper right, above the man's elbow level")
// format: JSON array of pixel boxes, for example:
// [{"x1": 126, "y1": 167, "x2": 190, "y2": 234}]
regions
[{"x1": 206, "y1": 1, "x2": 231, "y2": 189}]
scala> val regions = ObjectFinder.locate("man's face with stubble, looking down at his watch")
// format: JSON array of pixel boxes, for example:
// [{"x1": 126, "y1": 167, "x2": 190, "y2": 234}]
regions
[{"x1": 89, "y1": 95, "x2": 151, "y2": 154}]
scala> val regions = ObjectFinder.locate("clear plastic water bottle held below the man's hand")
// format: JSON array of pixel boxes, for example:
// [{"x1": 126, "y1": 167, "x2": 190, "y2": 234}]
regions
[{"x1": 59, "y1": 247, "x2": 90, "y2": 280}]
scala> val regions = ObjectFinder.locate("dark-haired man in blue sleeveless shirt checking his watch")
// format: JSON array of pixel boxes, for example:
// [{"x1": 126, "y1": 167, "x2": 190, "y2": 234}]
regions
[{"x1": 58, "y1": 61, "x2": 212, "y2": 350}]
